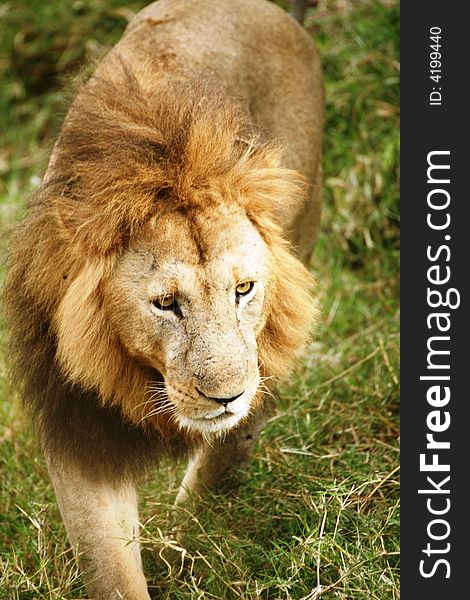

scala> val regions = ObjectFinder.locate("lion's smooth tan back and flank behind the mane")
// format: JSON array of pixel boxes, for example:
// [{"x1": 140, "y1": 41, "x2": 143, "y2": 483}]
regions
[{"x1": 111, "y1": 0, "x2": 324, "y2": 251}]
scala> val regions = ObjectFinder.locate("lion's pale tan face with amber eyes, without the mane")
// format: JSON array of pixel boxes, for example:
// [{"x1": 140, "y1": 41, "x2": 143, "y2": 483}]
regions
[{"x1": 103, "y1": 206, "x2": 270, "y2": 432}]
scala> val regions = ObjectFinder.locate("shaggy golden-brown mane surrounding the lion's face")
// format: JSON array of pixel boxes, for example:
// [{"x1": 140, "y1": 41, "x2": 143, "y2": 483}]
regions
[{"x1": 6, "y1": 60, "x2": 315, "y2": 476}]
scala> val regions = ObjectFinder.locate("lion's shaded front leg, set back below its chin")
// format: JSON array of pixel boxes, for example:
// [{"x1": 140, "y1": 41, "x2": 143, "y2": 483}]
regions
[{"x1": 176, "y1": 415, "x2": 266, "y2": 504}]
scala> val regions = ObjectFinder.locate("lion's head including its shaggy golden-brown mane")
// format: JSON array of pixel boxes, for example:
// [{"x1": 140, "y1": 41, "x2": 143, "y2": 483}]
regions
[{"x1": 4, "y1": 65, "x2": 315, "y2": 440}]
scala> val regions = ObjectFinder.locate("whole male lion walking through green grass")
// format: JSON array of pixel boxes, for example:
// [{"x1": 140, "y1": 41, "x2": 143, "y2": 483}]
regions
[{"x1": 6, "y1": 0, "x2": 323, "y2": 600}]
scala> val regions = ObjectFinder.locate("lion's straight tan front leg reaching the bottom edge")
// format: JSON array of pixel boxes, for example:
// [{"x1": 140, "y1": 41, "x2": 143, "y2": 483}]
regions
[{"x1": 46, "y1": 456, "x2": 150, "y2": 600}]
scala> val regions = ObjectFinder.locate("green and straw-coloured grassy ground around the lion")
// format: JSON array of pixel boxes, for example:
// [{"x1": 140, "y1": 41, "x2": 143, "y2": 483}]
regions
[{"x1": 0, "y1": 0, "x2": 399, "y2": 600}]
